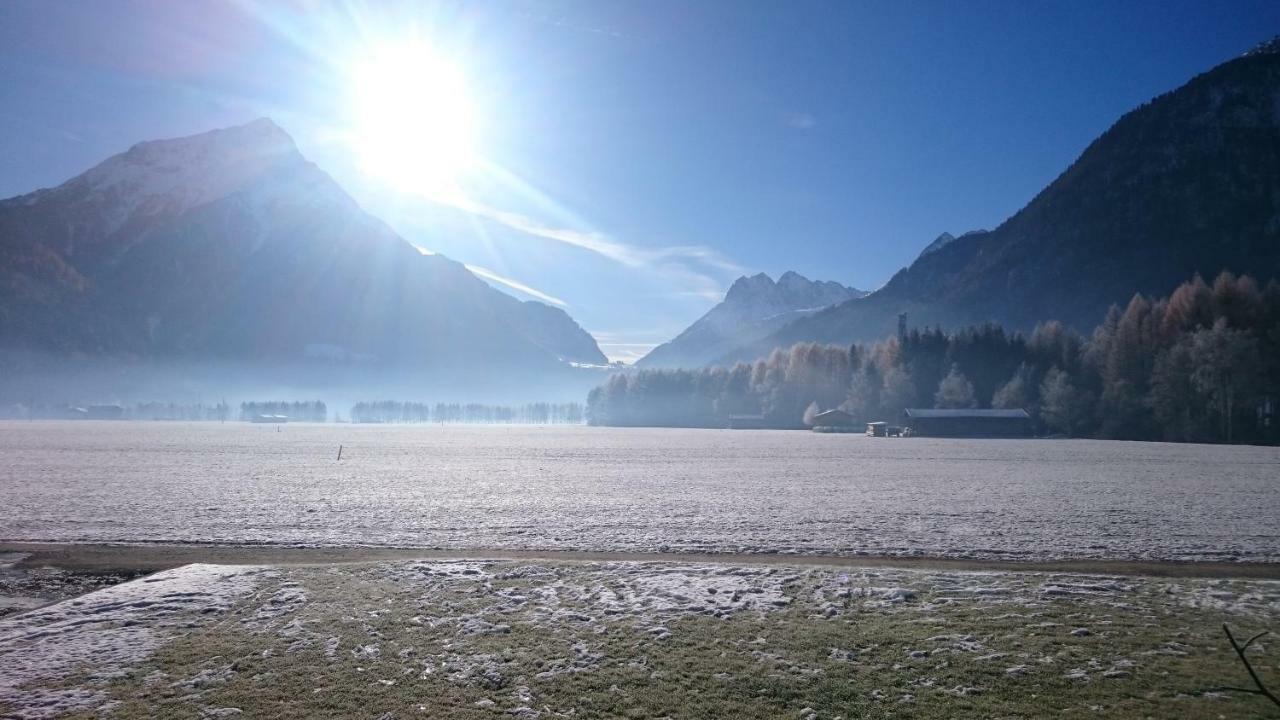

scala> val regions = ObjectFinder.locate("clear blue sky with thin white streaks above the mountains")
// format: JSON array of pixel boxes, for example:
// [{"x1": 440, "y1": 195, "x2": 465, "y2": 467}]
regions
[{"x1": 0, "y1": 0, "x2": 1280, "y2": 357}]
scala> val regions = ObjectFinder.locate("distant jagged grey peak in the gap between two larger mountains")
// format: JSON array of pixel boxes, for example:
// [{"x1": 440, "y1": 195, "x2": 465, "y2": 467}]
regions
[{"x1": 636, "y1": 272, "x2": 867, "y2": 368}]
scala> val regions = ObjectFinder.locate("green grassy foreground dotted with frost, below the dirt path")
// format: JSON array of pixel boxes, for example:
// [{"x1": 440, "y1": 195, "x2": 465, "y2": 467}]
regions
[{"x1": 15, "y1": 561, "x2": 1280, "y2": 720}]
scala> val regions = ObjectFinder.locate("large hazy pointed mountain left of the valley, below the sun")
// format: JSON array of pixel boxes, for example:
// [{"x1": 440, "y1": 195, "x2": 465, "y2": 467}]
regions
[{"x1": 0, "y1": 119, "x2": 607, "y2": 397}]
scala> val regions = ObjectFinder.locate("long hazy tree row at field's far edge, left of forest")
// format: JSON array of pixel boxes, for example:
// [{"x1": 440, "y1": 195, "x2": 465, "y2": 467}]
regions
[{"x1": 351, "y1": 400, "x2": 585, "y2": 425}]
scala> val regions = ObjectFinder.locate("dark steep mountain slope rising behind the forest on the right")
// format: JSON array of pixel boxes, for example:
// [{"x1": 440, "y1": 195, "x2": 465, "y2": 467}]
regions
[{"x1": 719, "y1": 40, "x2": 1280, "y2": 361}]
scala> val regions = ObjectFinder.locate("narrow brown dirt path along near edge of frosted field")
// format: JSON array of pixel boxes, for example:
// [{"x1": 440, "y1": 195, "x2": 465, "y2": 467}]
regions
[{"x1": 0, "y1": 542, "x2": 1280, "y2": 579}]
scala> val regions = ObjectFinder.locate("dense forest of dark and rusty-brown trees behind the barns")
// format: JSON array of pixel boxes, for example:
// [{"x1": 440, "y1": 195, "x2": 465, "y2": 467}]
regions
[{"x1": 586, "y1": 273, "x2": 1280, "y2": 443}]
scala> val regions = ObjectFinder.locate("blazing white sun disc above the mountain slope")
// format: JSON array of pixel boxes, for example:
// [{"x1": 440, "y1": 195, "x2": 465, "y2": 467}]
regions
[{"x1": 348, "y1": 42, "x2": 476, "y2": 193}]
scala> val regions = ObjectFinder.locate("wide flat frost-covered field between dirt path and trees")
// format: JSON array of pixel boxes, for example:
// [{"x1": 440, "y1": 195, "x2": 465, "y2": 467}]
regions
[{"x1": 0, "y1": 421, "x2": 1280, "y2": 562}]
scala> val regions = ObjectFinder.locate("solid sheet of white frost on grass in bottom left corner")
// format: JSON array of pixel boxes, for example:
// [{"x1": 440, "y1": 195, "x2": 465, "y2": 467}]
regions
[{"x1": 0, "y1": 565, "x2": 262, "y2": 717}]
